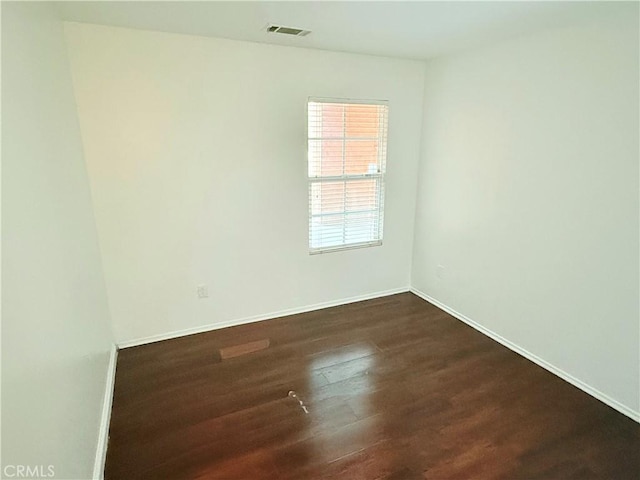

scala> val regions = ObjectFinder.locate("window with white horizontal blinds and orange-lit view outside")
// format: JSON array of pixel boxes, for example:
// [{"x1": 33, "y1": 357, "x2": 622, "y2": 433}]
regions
[{"x1": 308, "y1": 98, "x2": 388, "y2": 253}]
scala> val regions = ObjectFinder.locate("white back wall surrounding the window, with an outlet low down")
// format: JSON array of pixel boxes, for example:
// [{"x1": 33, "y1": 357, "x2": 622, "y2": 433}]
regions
[{"x1": 66, "y1": 23, "x2": 424, "y2": 342}]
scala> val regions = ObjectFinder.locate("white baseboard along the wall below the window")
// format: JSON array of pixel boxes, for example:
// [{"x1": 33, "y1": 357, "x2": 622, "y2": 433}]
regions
[{"x1": 118, "y1": 287, "x2": 410, "y2": 348}]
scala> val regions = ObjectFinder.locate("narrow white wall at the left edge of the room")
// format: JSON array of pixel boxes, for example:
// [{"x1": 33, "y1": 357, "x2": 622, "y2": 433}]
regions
[{"x1": 0, "y1": 2, "x2": 113, "y2": 479}]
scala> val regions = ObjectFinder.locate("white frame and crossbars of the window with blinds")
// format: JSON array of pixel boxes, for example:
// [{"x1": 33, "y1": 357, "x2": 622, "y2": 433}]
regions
[{"x1": 307, "y1": 97, "x2": 389, "y2": 255}]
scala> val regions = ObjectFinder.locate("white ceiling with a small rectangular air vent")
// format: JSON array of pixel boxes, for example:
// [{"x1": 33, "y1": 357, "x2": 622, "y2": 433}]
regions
[{"x1": 56, "y1": 1, "x2": 637, "y2": 59}]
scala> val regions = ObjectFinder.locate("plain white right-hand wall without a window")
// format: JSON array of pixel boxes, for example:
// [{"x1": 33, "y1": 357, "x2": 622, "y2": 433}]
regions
[{"x1": 412, "y1": 10, "x2": 640, "y2": 414}]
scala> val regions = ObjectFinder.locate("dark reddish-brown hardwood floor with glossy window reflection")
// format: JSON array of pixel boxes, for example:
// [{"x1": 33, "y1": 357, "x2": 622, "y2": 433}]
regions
[{"x1": 106, "y1": 293, "x2": 640, "y2": 480}]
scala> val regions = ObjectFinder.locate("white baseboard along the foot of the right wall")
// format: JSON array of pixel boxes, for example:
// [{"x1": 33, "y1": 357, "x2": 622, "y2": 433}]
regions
[{"x1": 410, "y1": 287, "x2": 640, "y2": 423}]
